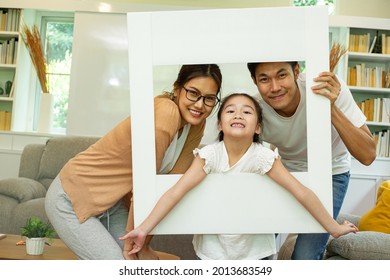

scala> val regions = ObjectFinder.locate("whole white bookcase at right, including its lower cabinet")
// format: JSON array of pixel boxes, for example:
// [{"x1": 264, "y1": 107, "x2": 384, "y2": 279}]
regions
[{"x1": 329, "y1": 16, "x2": 390, "y2": 215}]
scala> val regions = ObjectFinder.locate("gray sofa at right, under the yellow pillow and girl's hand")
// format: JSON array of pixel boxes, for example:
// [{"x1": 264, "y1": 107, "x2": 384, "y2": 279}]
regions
[{"x1": 278, "y1": 213, "x2": 390, "y2": 260}]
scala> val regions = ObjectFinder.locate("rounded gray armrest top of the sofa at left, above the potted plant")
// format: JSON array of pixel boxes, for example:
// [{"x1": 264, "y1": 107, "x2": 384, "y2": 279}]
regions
[{"x1": 0, "y1": 178, "x2": 46, "y2": 203}]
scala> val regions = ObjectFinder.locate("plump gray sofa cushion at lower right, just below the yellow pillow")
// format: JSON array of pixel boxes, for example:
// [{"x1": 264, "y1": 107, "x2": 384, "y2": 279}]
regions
[{"x1": 326, "y1": 231, "x2": 390, "y2": 260}]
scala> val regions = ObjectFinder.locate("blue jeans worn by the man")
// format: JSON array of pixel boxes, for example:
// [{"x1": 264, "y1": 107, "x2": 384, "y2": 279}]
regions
[{"x1": 291, "y1": 172, "x2": 350, "y2": 260}]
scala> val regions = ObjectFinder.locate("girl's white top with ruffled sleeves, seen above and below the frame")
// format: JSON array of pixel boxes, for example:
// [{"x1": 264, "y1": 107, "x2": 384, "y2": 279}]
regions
[{"x1": 193, "y1": 141, "x2": 279, "y2": 260}]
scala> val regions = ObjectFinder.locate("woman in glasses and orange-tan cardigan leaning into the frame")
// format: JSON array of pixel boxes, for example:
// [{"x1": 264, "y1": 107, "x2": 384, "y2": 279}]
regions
[{"x1": 45, "y1": 64, "x2": 222, "y2": 259}]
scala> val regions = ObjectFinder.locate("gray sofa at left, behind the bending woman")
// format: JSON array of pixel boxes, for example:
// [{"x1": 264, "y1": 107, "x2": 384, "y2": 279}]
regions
[{"x1": 0, "y1": 136, "x2": 196, "y2": 260}]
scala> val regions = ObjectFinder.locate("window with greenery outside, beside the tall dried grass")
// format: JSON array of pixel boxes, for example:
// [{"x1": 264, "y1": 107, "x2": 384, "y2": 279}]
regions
[{"x1": 35, "y1": 14, "x2": 74, "y2": 133}]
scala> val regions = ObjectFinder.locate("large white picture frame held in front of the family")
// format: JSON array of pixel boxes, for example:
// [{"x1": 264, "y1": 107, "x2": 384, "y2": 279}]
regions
[{"x1": 127, "y1": 7, "x2": 332, "y2": 234}]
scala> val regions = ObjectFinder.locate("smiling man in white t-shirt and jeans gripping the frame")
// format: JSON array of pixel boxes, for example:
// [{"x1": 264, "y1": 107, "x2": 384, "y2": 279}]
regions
[{"x1": 247, "y1": 62, "x2": 376, "y2": 260}]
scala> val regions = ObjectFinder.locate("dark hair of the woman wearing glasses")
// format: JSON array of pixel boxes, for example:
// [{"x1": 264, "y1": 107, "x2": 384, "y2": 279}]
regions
[{"x1": 173, "y1": 64, "x2": 222, "y2": 97}]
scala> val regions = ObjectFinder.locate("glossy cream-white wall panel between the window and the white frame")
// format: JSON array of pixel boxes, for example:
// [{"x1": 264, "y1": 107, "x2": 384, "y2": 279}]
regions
[{"x1": 66, "y1": 12, "x2": 130, "y2": 136}]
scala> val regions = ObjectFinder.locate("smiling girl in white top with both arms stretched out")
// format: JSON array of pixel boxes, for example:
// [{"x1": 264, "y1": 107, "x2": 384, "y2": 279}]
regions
[{"x1": 121, "y1": 94, "x2": 357, "y2": 259}]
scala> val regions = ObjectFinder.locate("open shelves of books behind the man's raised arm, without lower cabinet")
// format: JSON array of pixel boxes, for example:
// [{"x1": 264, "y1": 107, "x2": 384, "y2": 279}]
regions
[{"x1": 330, "y1": 18, "x2": 390, "y2": 161}]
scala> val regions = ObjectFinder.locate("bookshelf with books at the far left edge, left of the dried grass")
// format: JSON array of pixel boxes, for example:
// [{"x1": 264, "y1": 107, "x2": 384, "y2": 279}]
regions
[{"x1": 0, "y1": 8, "x2": 21, "y2": 131}]
